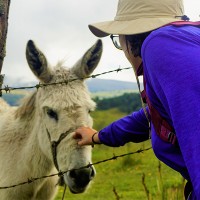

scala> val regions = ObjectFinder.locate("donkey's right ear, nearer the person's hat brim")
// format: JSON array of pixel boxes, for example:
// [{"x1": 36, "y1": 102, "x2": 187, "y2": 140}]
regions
[{"x1": 72, "y1": 40, "x2": 103, "y2": 78}]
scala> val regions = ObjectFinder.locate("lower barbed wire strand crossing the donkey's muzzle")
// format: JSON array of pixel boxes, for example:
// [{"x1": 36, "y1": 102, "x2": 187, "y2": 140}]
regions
[{"x1": 0, "y1": 147, "x2": 152, "y2": 190}]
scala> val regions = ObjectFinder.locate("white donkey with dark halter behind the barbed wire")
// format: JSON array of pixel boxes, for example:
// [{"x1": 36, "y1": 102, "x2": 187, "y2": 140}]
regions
[{"x1": 0, "y1": 40, "x2": 102, "y2": 200}]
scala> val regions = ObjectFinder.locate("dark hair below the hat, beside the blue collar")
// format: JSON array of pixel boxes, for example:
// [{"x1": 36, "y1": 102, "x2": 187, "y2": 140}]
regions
[{"x1": 126, "y1": 32, "x2": 151, "y2": 57}]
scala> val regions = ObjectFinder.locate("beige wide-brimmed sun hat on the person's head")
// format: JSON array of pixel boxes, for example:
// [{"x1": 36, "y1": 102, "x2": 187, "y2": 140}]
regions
[{"x1": 89, "y1": 0, "x2": 184, "y2": 37}]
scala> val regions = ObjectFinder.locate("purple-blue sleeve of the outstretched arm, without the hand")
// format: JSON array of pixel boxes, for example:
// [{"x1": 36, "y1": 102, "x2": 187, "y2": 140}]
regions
[{"x1": 99, "y1": 109, "x2": 149, "y2": 147}]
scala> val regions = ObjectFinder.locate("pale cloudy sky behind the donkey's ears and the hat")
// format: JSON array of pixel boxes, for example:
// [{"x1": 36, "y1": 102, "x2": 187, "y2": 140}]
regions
[{"x1": 2, "y1": 0, "x2": 200, "y2": 86}]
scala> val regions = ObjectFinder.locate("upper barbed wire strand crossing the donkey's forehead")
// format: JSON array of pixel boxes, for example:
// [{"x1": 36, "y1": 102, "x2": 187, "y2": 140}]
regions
[{"x1": 0, "y1": 67, "x2": 132, "y2": 93}]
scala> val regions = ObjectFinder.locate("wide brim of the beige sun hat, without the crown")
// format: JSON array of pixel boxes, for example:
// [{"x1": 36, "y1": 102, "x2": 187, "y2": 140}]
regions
[{"x1": 89, "y1": 17, "x2": 182, "y2": 37}]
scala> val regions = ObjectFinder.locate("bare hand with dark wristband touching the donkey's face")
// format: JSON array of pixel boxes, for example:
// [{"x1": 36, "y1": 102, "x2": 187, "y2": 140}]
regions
[{"x1": 73, "y1": 126, "x2": 100, "y2": 146}]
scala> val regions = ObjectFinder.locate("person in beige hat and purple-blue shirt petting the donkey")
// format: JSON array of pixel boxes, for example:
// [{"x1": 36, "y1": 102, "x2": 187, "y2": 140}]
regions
[{"x1": 74, "y1": 0, "x2": 200, "y2": 200}]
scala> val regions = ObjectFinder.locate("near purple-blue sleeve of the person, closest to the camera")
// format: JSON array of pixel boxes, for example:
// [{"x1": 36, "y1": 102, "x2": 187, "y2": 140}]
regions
[{"x1": 142, "y1": 27, "x2": 200, "y2": 197}]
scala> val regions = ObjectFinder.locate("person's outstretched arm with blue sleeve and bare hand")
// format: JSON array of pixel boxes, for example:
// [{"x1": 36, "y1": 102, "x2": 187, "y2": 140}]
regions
[{"x1": 74, "y1": 109, "x2": 149, "y2": 147}]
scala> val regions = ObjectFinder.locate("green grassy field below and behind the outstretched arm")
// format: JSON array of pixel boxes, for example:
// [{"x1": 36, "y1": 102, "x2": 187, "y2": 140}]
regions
[{"x1": 55, "y1": 109, "x2": 185, "y2": 200}]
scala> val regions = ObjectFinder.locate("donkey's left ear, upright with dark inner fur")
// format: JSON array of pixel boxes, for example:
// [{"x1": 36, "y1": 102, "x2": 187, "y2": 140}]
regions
[{"x1": 26, "y1": 40, "x2": 52, "y2": 83}]
